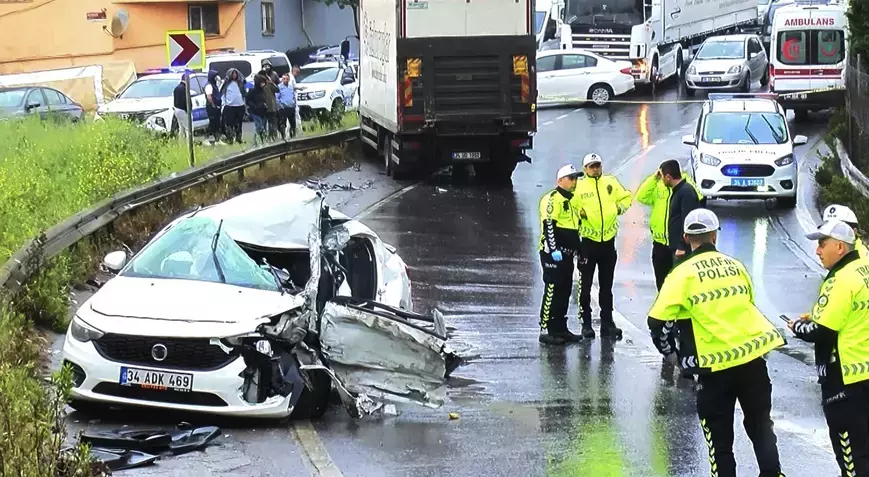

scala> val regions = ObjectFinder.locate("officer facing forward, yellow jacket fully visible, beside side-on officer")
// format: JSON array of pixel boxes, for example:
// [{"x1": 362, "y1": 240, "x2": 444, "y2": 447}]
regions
[{"x1": 573, "y1": 153, "x2": 631, "y2": 339}]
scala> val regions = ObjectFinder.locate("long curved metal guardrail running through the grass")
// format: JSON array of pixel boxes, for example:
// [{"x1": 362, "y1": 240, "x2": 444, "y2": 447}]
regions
[{"x1": 0, "y1": 127, "x2": 359, "y2": 290}]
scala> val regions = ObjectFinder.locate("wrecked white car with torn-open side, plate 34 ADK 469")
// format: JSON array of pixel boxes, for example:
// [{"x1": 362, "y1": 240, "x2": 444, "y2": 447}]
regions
[{"x1": 63, "y1": 184, "x2": 460, "y2": 418}]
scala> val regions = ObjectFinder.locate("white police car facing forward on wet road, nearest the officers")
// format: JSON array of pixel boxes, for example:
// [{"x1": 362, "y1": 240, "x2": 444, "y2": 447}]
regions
[{"x1": 682, "y1": 93, "x2": 808, "y2": 208}]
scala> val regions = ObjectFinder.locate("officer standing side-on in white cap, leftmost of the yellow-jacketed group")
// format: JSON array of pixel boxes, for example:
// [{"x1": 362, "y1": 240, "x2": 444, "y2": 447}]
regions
[{"x1": 538, "y1": 164, "x2": 582, "y2": 345}]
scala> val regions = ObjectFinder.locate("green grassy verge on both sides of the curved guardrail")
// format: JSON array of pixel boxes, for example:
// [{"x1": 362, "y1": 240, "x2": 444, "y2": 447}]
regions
[{"x1": 0, "y1": 115, "x2": 353, "y2": 477}]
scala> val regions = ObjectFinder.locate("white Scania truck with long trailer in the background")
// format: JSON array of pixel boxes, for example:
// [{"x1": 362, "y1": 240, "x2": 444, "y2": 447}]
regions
[{"x1": 548, "y1": 0, "x2": 757, "y2": 85}]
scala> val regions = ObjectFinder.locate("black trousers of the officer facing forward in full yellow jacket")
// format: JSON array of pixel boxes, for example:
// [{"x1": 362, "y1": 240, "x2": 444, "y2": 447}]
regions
[{"x1": 579, "y1": 238, "x2": 618, "y2": 328}]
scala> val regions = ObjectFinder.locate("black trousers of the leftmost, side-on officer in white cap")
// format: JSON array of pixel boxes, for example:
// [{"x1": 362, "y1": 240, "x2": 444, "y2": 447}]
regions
[{"x1": 540, "y1": 250, "x2": 574, "y2": 333}]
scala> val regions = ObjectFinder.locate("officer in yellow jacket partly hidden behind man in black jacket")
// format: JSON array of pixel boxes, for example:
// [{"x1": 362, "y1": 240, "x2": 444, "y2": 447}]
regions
[{"x1": 637, "y1": 159, "x2": 703, "y2": 290}]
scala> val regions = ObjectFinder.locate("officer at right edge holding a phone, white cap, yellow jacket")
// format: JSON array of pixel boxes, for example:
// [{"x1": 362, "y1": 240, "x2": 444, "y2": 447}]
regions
[{"x1": 788, "y1": 218, "x2": 869, "y2": 477}]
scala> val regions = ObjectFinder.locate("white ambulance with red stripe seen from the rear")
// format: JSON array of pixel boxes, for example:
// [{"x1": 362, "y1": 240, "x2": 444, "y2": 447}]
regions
[{"x1": 769, "y1": 2, "x2": 848, "y2": 120}]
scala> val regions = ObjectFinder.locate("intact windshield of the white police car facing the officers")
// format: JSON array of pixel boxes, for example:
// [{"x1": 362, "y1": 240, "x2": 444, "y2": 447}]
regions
[{"x1": 703, "y1": 113, "x2": 788, "y2": 144}]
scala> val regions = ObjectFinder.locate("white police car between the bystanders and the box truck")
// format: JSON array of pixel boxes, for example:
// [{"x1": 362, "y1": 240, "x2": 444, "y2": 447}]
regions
[{"x1": 296, "y1": 61, "x2": 359, "y2": 120}]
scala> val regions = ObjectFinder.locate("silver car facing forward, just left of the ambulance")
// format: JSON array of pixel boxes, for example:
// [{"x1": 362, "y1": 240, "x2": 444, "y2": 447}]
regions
[{"x1": 685, "y1": 34, "x2": 769, "y2": 96}]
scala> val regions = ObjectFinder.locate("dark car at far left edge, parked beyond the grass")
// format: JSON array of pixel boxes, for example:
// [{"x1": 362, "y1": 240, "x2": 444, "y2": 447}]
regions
[{"x1": 0, "y1": 86, "x2": 84, "y2": 122}]
